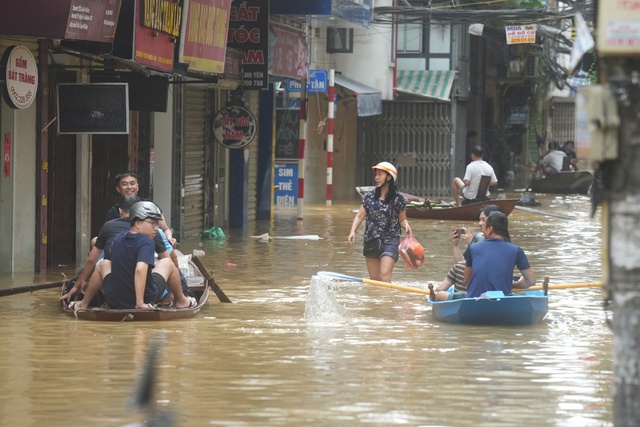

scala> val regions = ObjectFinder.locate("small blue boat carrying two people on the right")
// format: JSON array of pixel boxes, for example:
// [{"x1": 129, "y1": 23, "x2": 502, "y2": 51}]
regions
[{"x1": 427, "y1": 290, "x2": 549, "y2": 326}]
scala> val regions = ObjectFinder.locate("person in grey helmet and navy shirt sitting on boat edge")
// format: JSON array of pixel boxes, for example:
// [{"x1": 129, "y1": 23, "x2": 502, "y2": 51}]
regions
[{"x1": 69, "y1": 201, "x2": 197, "y2": 310}]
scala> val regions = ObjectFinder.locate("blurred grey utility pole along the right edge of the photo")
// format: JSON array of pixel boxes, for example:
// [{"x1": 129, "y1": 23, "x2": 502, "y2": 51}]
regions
[{"x1": 596, "y1": 0, "x2": 640, "y2": 427}]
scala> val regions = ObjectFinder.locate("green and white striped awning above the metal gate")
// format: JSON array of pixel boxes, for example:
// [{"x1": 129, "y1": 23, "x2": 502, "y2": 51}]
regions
[{"x1": 396, "y1": 70, "x2": 456, "y2": 101}]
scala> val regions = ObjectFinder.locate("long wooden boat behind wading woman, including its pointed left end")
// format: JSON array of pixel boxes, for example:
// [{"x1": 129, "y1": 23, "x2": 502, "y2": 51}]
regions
[{"x1": 356, "y1": 186, "x2": 520, "y2": 221}]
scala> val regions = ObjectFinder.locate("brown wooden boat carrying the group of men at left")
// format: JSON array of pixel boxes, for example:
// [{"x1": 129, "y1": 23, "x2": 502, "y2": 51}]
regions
[{"x1": 61, "y1": 251, "x2": 212, "y2": 322}]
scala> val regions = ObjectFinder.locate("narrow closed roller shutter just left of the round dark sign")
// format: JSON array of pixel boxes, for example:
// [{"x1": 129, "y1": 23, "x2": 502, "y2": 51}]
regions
[{"x1": 181, "y1": 85, "x2": 206, "y2": 239}]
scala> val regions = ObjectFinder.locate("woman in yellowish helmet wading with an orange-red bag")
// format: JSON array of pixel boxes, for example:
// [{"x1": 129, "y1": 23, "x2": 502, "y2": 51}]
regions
[{"x1": 347, "y1": 162, "x2": 411, "y2": 282}]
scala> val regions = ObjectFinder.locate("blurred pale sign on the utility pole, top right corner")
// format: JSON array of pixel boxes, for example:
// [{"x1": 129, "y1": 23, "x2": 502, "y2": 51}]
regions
[{"x1": 596, "y1": 0, "x2": 640, "y2": 57}]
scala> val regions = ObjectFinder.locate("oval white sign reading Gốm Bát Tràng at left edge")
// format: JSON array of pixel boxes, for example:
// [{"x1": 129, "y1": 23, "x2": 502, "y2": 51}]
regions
[{"x1": 2, "y1": 46, "x2": 38, "y2": 109}]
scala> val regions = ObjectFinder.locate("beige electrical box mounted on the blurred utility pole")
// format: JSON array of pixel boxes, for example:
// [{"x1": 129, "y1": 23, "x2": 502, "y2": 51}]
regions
[{"x1": 575, "y1": 85, "x2": 620, "y2": 162}]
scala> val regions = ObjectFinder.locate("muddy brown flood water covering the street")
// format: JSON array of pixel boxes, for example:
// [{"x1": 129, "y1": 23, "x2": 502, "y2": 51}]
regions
[{"x1": 0, "y1": 194, "x2": 612, "y2": 427}]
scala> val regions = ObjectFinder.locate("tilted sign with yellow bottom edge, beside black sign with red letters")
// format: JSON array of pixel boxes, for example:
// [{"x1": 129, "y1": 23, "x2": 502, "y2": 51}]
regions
[{"x1": 180, "y1": 0, "x2": 231, "y2": 74}]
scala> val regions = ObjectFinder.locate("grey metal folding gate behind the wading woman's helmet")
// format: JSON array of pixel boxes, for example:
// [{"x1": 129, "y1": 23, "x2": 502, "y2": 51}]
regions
[{"x1": 357, "y1": 101, "x2": 453, "y2": 197}]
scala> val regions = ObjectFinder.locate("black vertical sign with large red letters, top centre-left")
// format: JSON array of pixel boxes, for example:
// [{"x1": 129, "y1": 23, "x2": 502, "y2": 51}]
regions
[{"x1": 227, "y1": 0, "x2": 269, "y2": 90}]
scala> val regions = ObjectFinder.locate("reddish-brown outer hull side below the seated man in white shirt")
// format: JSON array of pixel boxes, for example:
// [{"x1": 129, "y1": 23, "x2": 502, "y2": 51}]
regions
[{"x1": 407, "y1": 199, "x2": 520, "y2": 221}]
